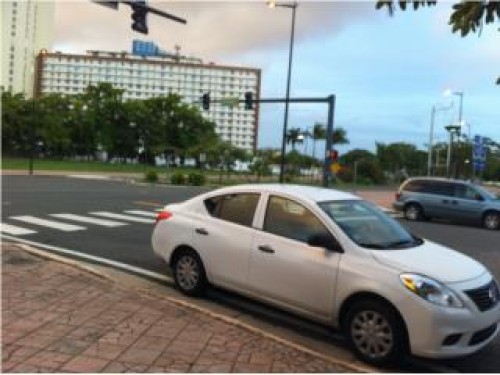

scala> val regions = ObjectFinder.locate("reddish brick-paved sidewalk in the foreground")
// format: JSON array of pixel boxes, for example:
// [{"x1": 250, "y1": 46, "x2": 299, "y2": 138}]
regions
[{"x1": 2, "y1": 243, "x2": 356, "y2": 373}]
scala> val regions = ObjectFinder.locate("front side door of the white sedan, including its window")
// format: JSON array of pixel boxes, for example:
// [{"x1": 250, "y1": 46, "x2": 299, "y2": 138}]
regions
[{"x1": 248, "y1": 195, "x2": 340, "y2": 319}]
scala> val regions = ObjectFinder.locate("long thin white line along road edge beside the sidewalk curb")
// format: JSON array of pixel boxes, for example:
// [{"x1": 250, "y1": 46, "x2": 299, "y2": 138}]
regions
[{"x1": 1, "y1": 234, "x2": 172, "y2": 282}]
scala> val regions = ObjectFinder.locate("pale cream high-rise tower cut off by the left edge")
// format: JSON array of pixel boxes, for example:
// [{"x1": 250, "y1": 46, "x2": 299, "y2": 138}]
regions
[{"x1": 0, "y1": 0, "x2": 55, "y2": 97}]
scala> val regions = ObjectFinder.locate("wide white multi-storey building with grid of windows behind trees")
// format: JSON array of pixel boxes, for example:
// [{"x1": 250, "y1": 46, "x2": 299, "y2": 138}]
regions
[{"x1": 35, "y1": 51, "x2": 261, "y2": 151}]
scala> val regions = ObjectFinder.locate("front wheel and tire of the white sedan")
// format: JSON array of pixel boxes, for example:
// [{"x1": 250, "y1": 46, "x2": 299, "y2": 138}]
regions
[{"x1": 344, "y1": 299, "x2": 408, "y2": 366}]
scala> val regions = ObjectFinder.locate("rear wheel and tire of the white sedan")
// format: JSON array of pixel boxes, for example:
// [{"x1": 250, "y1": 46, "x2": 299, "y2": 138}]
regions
[{"x1": 173, "y1": 250, "x2": 207, "y2": 296}]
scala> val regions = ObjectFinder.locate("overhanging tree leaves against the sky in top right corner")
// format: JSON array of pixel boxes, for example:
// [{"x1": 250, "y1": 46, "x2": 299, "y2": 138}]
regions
[{"x1": 375, "y1": 0, "x2": 500, "y2": 85}]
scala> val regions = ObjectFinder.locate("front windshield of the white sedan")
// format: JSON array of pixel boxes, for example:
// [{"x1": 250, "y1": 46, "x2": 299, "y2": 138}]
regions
[{"x1": 318, "y1": 200, "x2": 423, "y2": 249}]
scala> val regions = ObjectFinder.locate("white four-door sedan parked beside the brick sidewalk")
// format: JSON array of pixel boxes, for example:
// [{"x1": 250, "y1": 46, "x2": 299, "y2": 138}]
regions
[{"x1": 152, "y1": 185, "x2": 500, "y2": 364}]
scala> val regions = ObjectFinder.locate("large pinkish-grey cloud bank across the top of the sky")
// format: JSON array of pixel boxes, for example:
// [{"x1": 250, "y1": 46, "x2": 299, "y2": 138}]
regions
[{"x1": 55, "y1": 1, "x2": 377, "y2": 60}]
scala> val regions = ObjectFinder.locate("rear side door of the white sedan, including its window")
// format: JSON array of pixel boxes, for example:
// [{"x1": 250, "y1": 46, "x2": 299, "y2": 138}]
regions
[{"x1": 194, "y1": 193, "x2": 261, "y2": 289}]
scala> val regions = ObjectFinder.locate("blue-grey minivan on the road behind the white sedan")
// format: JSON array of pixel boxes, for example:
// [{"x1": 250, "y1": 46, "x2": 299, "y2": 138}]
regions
[{"x1": 392, "y1": 177, "x2": 500, "y2": 230}]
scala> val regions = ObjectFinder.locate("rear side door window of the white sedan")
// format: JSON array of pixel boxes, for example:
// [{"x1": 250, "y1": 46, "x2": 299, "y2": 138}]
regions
[{"x1": 205, "y1": 193, "x2": 260, "y2": 227}]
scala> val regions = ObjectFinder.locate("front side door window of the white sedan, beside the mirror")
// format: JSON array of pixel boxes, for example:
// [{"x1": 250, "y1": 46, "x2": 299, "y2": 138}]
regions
[{"x1": 263, "y1": 196, "x2": 329, "y2": 243}]
